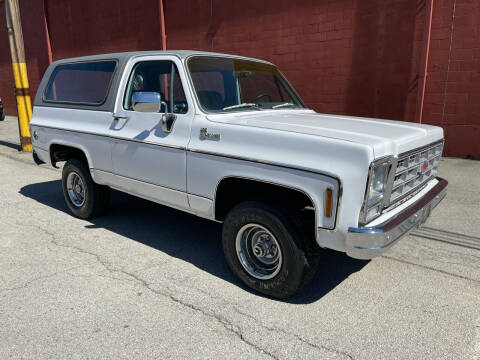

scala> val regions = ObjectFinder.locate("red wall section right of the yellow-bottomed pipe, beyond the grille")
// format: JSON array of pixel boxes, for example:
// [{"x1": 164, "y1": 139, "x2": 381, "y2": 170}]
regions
[{"x1": 424, "y1": 0, "x2": 480, "y2": 159}]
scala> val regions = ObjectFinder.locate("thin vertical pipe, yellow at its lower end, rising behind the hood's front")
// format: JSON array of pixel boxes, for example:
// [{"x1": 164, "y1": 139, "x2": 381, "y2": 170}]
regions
[{"x1": 415, "y1": 0, "x2": 434, "y2": 124}]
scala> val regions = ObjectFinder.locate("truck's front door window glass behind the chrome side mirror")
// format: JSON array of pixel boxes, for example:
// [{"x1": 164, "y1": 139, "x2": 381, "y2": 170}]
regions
[{"x1": 123, "y1": 60, "x2": 188, "y2": 114}]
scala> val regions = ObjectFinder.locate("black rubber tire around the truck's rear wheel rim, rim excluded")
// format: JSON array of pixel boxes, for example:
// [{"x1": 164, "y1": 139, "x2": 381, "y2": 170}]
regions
[{"x1": 62, "y1": 159, "x2": 110, "y2": 219}]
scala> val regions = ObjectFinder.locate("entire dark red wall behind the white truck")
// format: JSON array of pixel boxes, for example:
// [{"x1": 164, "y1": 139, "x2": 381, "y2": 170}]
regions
[{"x1": 0, "y1": 0, "x2": 480, "y2": 159}]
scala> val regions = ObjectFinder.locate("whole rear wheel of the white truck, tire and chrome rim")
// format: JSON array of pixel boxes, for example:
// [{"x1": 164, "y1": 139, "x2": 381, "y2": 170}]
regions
[{"x1": 62, "y1": 159, "x2": 110, "y2": 219}]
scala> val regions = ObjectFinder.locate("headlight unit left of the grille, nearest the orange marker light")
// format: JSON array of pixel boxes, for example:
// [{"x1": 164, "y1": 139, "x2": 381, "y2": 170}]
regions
[{"x1": 360, "y1": 158, "x2": 392, "y2": 225}]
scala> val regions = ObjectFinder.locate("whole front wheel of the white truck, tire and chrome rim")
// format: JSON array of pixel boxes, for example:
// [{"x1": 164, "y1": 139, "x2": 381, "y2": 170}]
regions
[{"x1": 222, "y1": 201, "x2": 316, "y2": 299}]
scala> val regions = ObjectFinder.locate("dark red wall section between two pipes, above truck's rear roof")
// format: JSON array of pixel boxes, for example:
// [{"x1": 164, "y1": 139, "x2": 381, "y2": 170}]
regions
[{"x1": 48, "y1": 0, "x2": 162, "y2": 60}]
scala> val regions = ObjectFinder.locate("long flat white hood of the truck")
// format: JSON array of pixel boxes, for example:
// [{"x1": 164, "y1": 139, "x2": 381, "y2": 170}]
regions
[{"x1": 208, "y1": 110, "x2": 443, "y2": 158}]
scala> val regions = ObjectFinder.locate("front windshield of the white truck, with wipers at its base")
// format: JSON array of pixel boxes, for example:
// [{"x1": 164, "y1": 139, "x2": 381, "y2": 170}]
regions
[{"x1": 188, "y1": 56, "x2": 305, "y2": 112}]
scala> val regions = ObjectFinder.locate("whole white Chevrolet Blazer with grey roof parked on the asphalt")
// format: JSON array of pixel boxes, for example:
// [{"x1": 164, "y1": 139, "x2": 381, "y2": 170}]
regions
[{"x1": 30, "y1": 51, "x2": 447, "y2": 298}]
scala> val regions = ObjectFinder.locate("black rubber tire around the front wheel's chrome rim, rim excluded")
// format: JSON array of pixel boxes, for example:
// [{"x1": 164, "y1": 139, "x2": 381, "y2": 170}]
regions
[{"x1": 222, "y1": 201, "x2": 318, "y2": 299}]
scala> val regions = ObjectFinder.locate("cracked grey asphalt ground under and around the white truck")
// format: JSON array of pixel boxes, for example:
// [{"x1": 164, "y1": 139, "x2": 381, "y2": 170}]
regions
[{"x1": 0, "y1": 119, "x2": 480, "y2": 360}]
